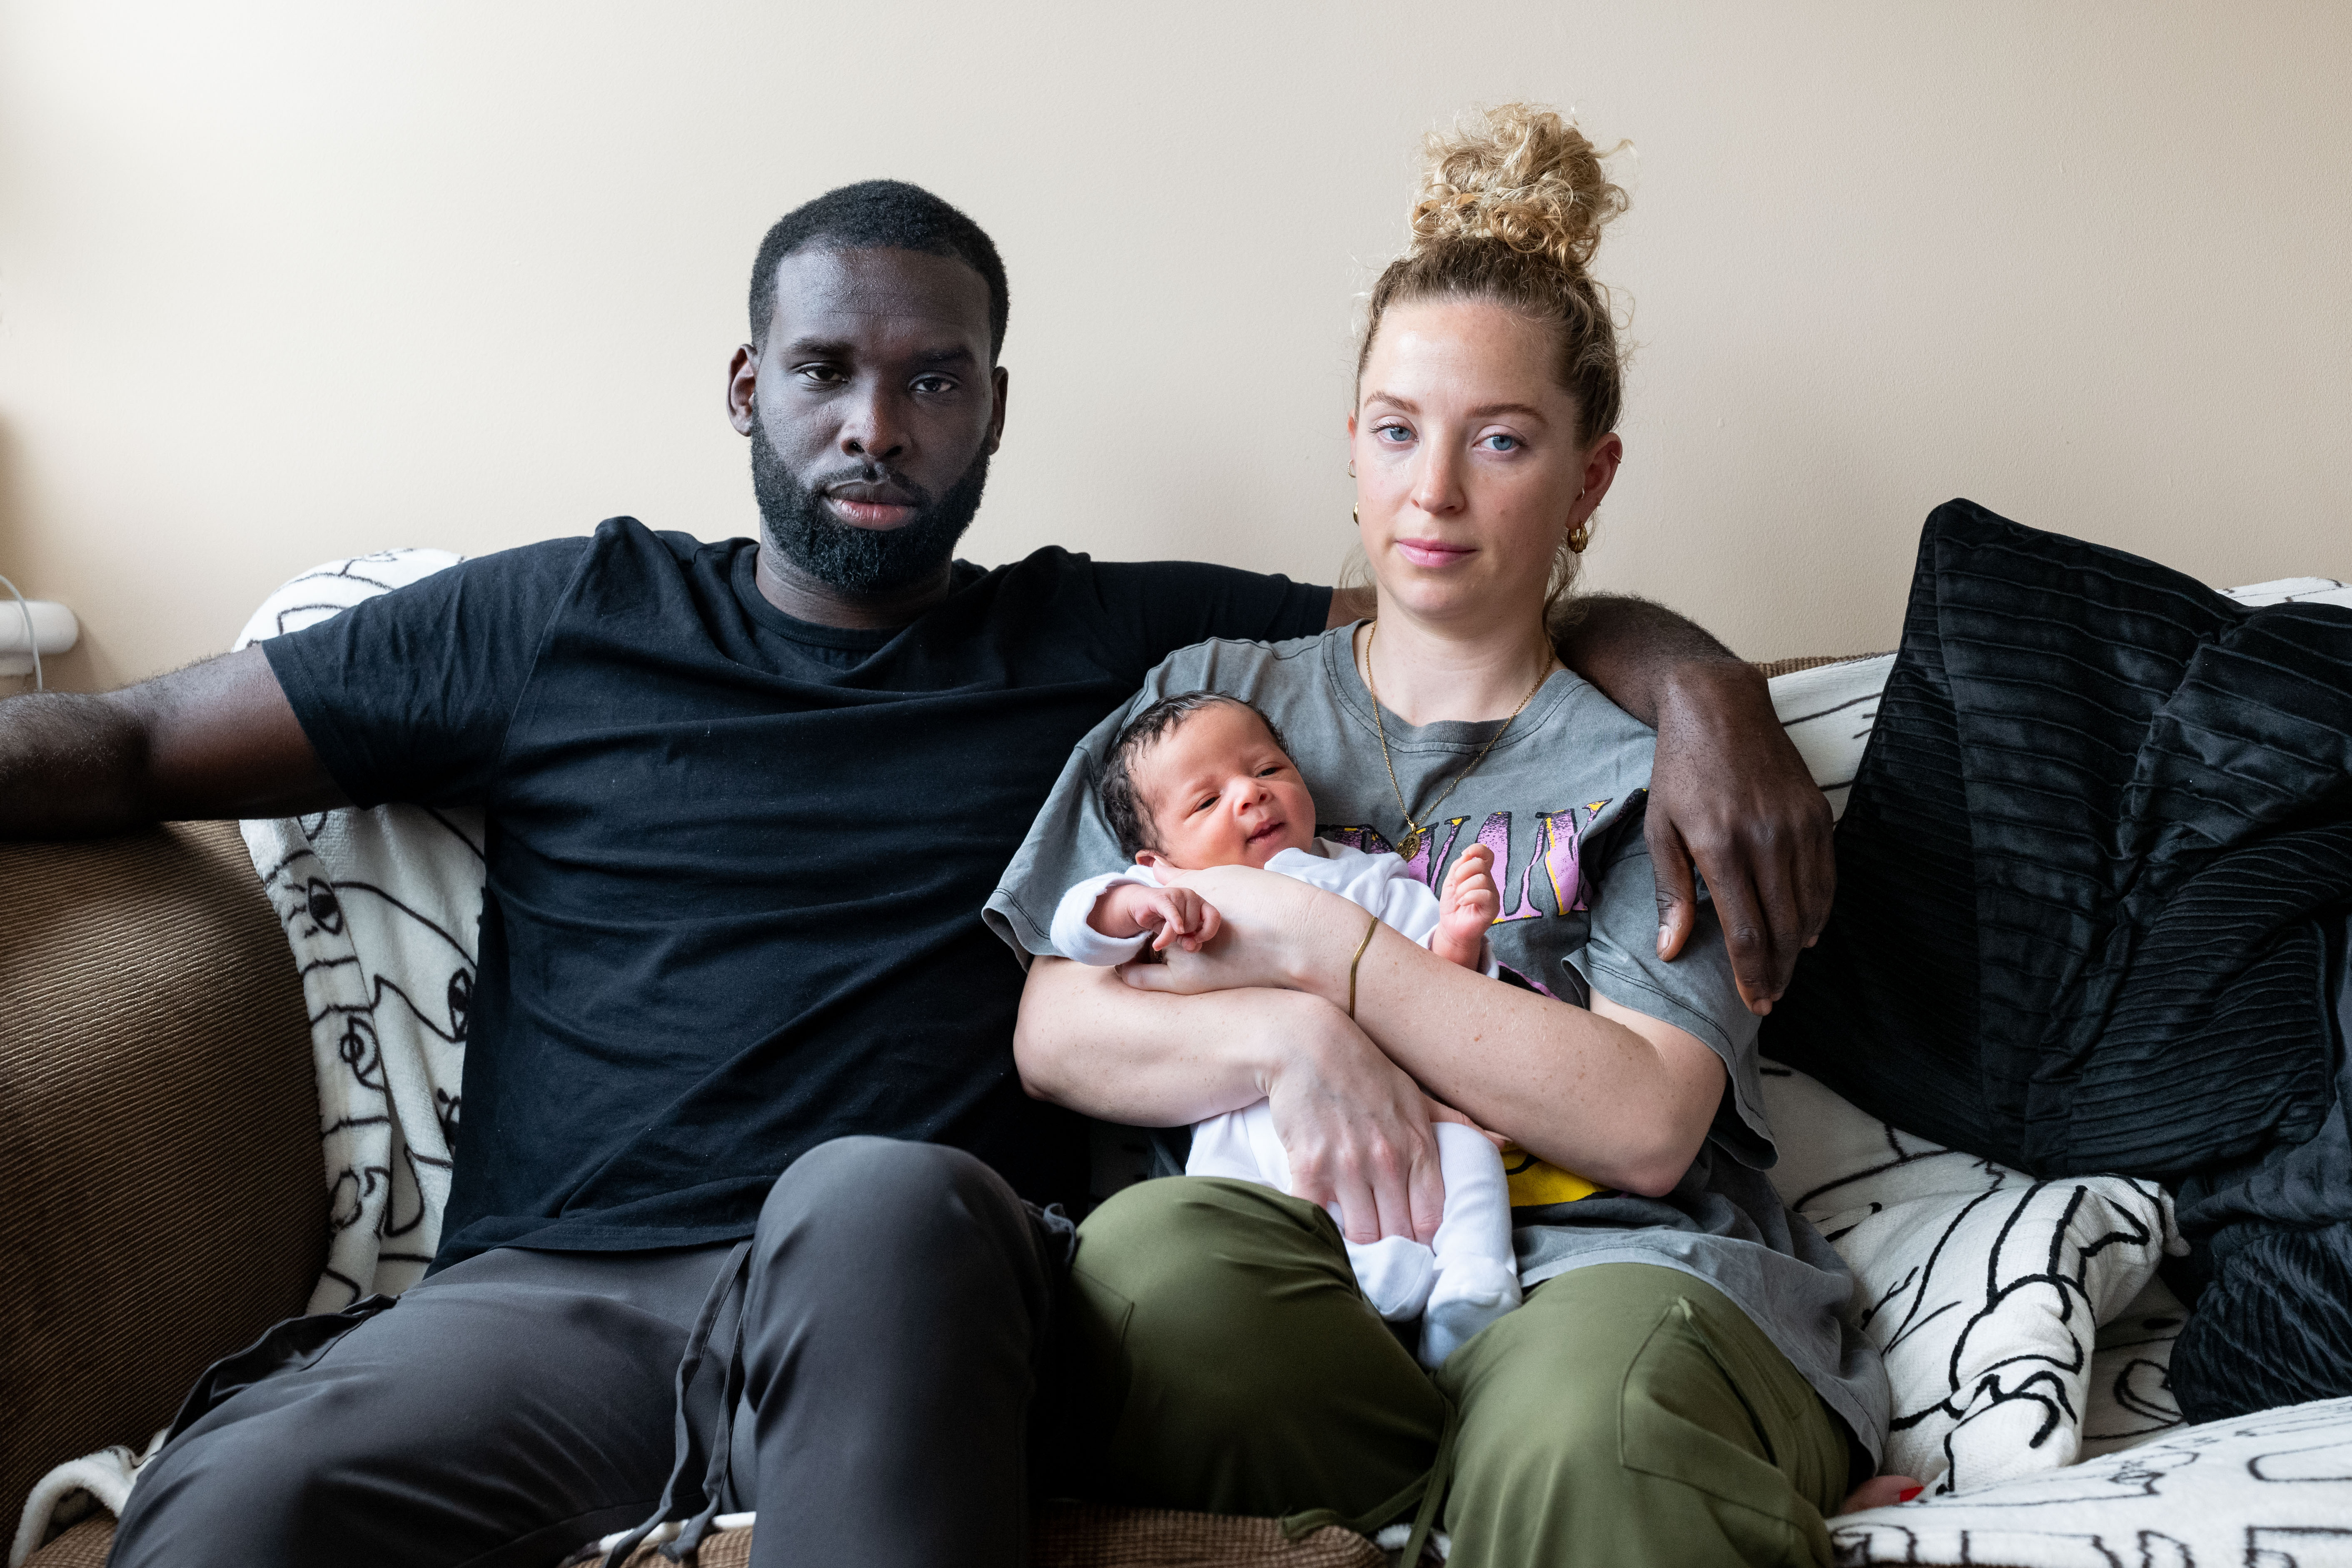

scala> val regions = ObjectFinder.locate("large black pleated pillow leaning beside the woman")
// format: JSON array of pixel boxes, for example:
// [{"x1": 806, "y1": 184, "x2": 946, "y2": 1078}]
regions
[{"x1": 1764, "y1": 501, "x2": 2352, "y2": 1415}]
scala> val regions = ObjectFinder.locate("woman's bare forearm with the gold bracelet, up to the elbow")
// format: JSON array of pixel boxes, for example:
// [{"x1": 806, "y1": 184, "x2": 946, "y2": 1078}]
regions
[{"x1": 1301, "y1": 926, "x2": 1724, "y2": 1194}]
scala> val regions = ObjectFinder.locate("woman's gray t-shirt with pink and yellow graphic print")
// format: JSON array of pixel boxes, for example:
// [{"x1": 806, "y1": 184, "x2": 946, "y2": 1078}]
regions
[{"x1": 988, "y1": 628, "x2": 1889, "y2": 1455}]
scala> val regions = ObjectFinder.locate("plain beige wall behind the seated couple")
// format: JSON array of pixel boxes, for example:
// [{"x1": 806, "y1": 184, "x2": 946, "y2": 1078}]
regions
[{"x1": 0, "y1": 0, "x2": 2352, "y2": 686}]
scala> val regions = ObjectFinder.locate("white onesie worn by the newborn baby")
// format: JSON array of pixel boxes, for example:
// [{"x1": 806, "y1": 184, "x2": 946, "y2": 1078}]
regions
[{"x1": 1054, "y1": 839, "x2": 1519, "y2": 1368}]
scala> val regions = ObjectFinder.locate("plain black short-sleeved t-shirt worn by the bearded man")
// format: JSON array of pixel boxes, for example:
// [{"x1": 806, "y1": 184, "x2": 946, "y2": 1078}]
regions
[{"x1": 261, "y1": 517, "x2": 1329, "y2": 1267}]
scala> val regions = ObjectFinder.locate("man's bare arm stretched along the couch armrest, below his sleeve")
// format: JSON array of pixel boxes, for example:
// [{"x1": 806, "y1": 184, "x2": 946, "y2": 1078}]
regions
[{"x1": 0, "y1": 649, "x2": 350, "y2": 839}]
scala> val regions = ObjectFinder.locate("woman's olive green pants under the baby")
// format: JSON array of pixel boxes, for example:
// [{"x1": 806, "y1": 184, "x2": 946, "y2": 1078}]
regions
[{"x1": 1049, "y1": 1178, "x2": 1849, "y2": 1568}]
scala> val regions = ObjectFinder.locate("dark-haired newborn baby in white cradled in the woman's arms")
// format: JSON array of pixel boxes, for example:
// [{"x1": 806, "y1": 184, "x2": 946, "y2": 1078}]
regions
[{"x1": 1054, "y1": 691, "x2": 1519, "y2": 1368}]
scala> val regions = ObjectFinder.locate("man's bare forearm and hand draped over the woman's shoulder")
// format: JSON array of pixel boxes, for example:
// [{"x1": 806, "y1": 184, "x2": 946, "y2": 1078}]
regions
[{"x1": 1331, "y1": 588, "x2": 1837, "y2": 1013}]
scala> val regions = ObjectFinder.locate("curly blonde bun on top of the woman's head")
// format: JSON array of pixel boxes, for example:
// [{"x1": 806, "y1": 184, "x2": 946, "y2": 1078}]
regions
[{"x1": 1409, "y1": 103, "x2": 1625, "y2": 273}]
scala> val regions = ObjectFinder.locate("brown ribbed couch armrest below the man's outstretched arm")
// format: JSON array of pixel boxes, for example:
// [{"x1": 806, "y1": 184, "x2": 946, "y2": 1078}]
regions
[{"x1": 0, "y1": 823, "x2": 327, "y2": 1521}]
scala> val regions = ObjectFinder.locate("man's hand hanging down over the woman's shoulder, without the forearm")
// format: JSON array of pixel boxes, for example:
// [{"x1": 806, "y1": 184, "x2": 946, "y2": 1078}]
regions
[{"x1": 1644, "y1": 661, "x2": 1837, "y2": 1013}]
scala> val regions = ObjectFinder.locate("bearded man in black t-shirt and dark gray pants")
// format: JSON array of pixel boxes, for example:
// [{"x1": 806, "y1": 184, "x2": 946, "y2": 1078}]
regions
[{"x1": 0, "y1": 181, "x2": 1828, "y2": 1566}]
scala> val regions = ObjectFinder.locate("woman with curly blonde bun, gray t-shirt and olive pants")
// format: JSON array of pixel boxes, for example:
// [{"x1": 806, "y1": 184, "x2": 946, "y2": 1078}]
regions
[{"x1": 990, "y1": 106, "x2": 1891, "y2": 1568}]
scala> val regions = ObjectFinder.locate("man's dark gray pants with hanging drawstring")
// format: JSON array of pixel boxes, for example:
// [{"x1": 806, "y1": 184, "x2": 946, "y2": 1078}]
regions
[{"x1": 110, "y1": 1138, "x2": 1063, "y2": 1568}]
